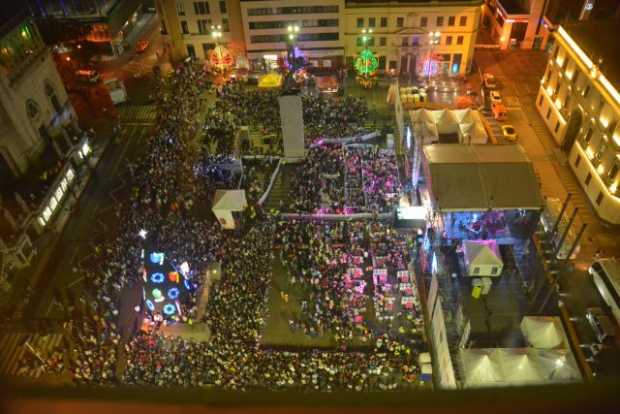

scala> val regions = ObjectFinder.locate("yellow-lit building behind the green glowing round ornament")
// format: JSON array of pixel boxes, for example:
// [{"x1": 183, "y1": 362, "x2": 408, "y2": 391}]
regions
[{"x1": 344, "y1": 0, "x2": 482, "y2": 75}]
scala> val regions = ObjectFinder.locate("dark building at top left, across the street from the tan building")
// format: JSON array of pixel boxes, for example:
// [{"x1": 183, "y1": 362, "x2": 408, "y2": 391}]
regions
[{"x1": 28, "y1": 0, "x2": 145, "y2": 55}]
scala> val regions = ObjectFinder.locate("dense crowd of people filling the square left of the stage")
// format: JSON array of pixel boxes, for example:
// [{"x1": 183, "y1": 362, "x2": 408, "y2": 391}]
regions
[{"x1": 12, "y1": 62, "x2": 426, "y2": 391}]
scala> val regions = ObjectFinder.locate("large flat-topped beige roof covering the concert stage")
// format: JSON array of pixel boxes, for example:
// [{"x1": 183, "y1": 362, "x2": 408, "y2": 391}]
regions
[{"x1": 424, "y1": 144, "x2": 543, "y2": 211}]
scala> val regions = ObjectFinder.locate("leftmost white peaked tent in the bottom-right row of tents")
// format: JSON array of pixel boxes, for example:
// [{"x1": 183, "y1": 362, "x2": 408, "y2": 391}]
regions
[{"x1": 460, "y1": 349, "x2": 503, "y2": 387}]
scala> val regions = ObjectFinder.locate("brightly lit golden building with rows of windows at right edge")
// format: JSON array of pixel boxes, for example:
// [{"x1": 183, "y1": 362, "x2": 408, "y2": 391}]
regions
[{"x1": 536, "y1": 21, "x2": 620, "y2": 224}]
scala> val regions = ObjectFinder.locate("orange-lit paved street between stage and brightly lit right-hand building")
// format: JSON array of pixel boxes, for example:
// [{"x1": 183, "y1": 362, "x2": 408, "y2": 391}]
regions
[{"x1": 475, "y1": 51, "x2": 620, "y2": 375}]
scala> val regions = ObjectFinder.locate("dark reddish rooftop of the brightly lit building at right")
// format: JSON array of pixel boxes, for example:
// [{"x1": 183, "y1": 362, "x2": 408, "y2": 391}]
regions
[{"x1": 562, "y1": 20, "x2": 620, "y2": 89}]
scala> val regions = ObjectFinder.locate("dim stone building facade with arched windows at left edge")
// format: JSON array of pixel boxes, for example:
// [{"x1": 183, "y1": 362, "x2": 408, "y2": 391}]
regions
[{"x1": 0, "y1": 17, "x2": 77, "y2": 179}]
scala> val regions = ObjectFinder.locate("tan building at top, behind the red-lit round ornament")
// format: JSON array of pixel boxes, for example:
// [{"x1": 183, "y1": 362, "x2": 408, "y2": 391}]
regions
[{"x1": 155, "y1": 0, "x2": 245, "y2": 61}]
